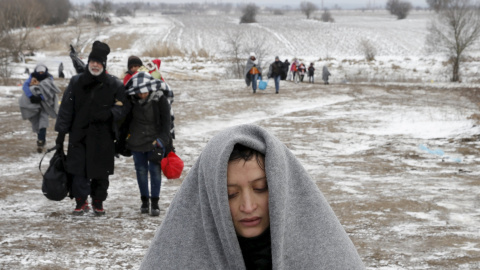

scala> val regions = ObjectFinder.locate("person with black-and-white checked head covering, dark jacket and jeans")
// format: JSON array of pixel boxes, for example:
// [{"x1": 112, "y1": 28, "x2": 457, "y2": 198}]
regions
[{"x1": 120, "y1": 71, "x2": 172, "y2": 216}]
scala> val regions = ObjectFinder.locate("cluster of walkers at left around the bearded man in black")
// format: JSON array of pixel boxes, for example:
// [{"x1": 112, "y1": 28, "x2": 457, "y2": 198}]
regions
[{"x1": 19, "y1": 41, "x2": 174, "y2": 216}]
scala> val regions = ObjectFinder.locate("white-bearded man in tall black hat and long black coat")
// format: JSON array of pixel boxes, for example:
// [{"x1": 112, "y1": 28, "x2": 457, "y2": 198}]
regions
[{"x1": 55, "y1": 41, "x2": 127, "y2": 215}]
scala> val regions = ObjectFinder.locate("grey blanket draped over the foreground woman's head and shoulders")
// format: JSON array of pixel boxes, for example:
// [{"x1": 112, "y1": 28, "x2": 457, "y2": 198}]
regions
[{"x1": 140, "y1": 125, "x2": 364, "y2": 270}]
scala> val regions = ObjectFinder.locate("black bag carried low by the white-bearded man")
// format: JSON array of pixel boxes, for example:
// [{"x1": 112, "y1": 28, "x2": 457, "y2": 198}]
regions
[{"x1": 38, "y1": 146, "x2": 72, "y2": 201}]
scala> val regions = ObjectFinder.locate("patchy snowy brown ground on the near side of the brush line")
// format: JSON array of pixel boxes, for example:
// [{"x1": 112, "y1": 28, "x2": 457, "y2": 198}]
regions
[{"x1": 0, "y1": 80, "x2": 480, "y2": 269}]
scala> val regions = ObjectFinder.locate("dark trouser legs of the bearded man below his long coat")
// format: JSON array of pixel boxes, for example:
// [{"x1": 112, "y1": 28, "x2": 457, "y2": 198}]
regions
[{"x1": 72, "y1": 175, "x2": 110, "y2": 201}]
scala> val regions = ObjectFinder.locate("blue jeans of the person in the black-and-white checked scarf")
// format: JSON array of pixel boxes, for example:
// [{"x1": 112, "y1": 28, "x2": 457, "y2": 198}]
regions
[{"x1": 132, "y1": 151, "x2": 162, "y2": 198}]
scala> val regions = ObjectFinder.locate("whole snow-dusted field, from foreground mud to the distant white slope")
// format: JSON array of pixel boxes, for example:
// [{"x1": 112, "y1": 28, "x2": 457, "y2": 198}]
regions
[{"x1": 0, "y1": 11, "x2": 480, "y2": 270}]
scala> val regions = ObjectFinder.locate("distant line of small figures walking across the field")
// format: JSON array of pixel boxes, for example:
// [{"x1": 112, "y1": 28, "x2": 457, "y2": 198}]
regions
[{"x1": 244, "y1": 52, "x2": 331, "y2": 94}]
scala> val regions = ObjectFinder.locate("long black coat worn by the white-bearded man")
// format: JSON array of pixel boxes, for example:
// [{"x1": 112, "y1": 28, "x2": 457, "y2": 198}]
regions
[{"x1": 55, "y1": 70, "x2": 127, "y2": 179}]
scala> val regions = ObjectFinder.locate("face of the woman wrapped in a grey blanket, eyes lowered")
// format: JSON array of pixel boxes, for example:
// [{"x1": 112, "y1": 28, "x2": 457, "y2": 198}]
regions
[{"x1": 227, "y1": 157, "x2": 270, "y2": 238}]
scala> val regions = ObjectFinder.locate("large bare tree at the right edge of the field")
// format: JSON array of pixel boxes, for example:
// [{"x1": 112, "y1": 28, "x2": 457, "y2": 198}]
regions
[{"x1": 426, "y1": 0, "x2": 480, "y2": 82}]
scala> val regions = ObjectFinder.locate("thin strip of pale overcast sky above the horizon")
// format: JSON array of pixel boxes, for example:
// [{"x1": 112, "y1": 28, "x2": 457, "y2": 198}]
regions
[{"x1": 71, "y1": 0, "x2": 426, "y2": 9}]
